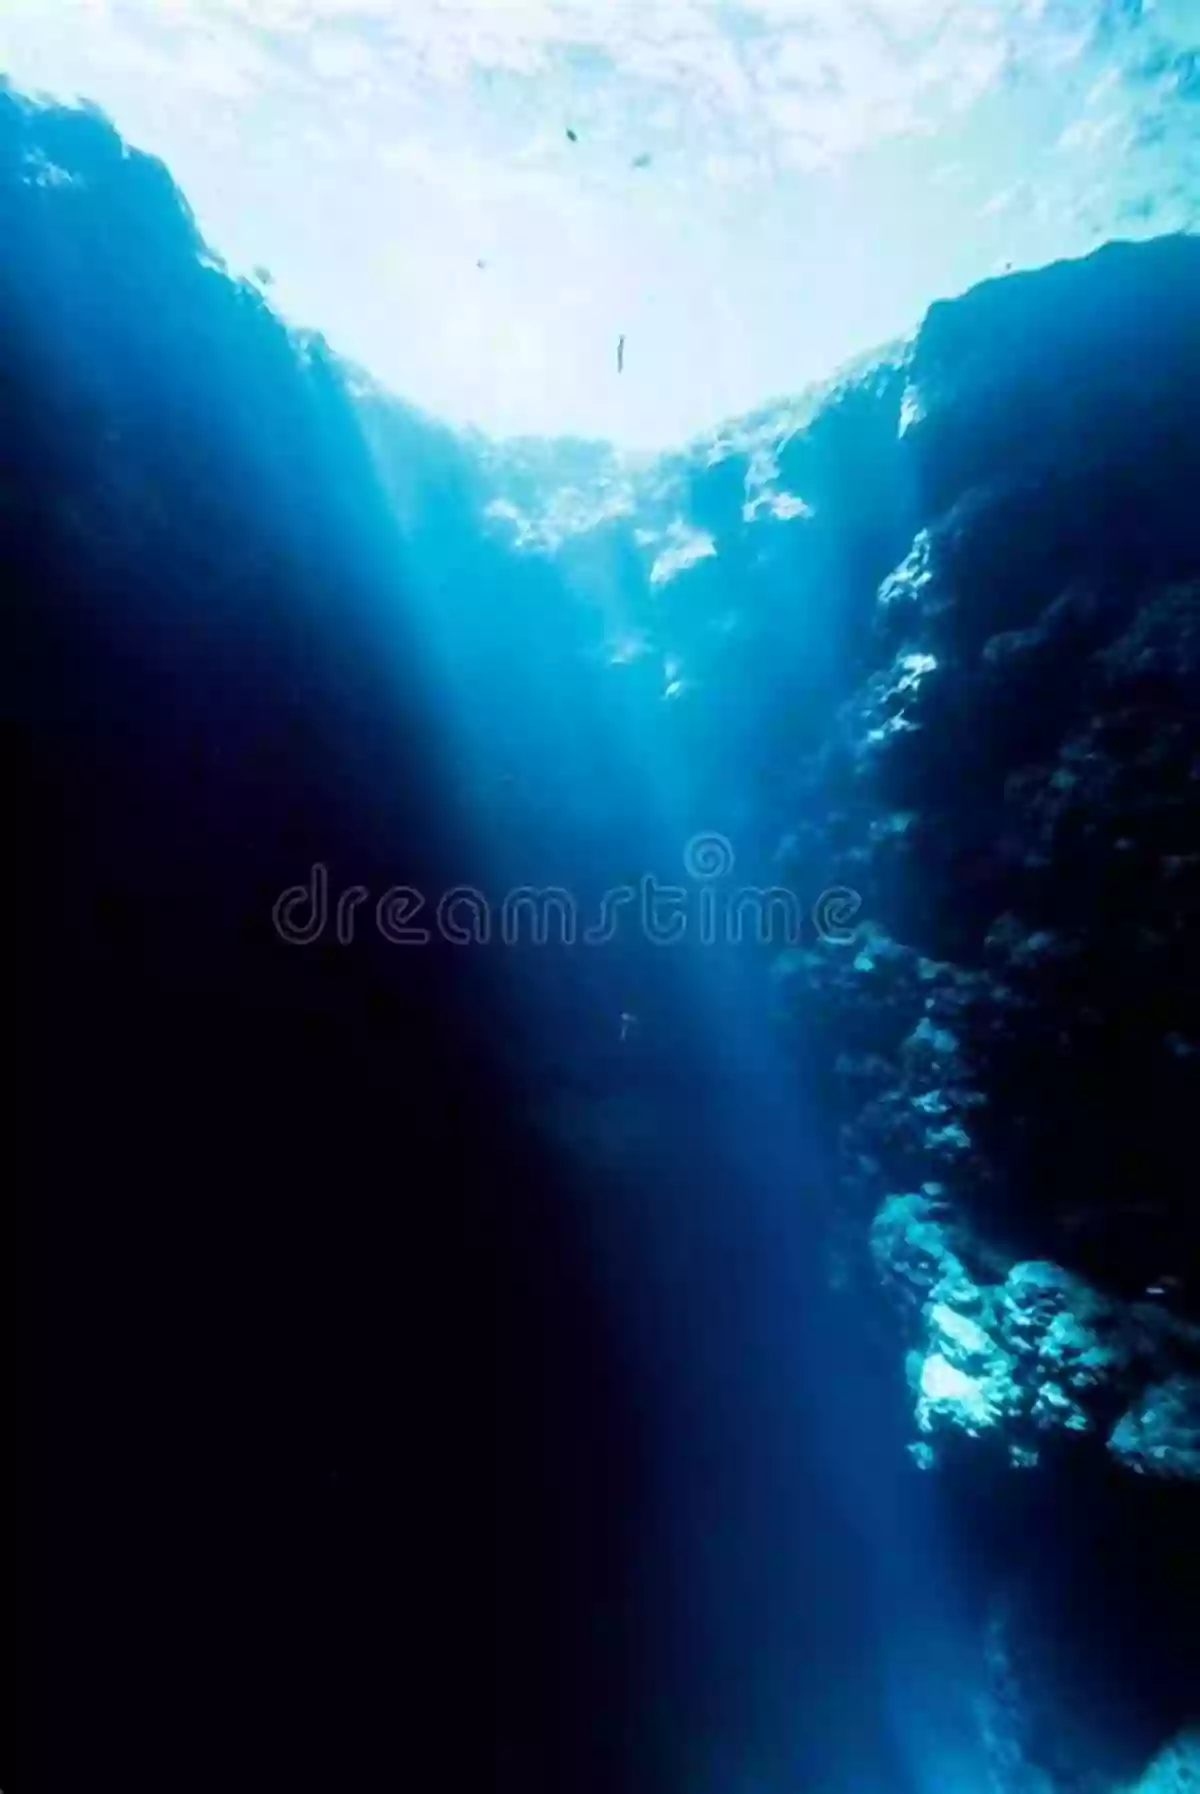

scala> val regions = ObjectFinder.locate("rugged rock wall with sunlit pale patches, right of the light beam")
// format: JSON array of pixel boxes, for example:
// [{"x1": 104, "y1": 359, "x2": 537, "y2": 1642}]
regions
[{"x1": 767, "y1": 239, "x2": 1200, "y2": 1476}]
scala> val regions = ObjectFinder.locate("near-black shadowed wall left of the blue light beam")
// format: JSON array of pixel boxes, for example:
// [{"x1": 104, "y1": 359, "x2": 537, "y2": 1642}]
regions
[{"x1": 0, "y1": 93, "x2": 653, "y2": 1794}]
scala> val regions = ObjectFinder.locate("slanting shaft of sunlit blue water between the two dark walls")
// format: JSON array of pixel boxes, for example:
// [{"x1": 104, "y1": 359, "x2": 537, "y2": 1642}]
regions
[{"x1": 374, "y1": 423, "x2": 985, "y2": 1794}]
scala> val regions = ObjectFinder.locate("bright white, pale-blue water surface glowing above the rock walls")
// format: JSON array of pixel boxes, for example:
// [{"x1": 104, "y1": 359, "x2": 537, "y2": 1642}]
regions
[{"x1": 0, "y1": 0, "x2": 1200, "y2": 447}]
